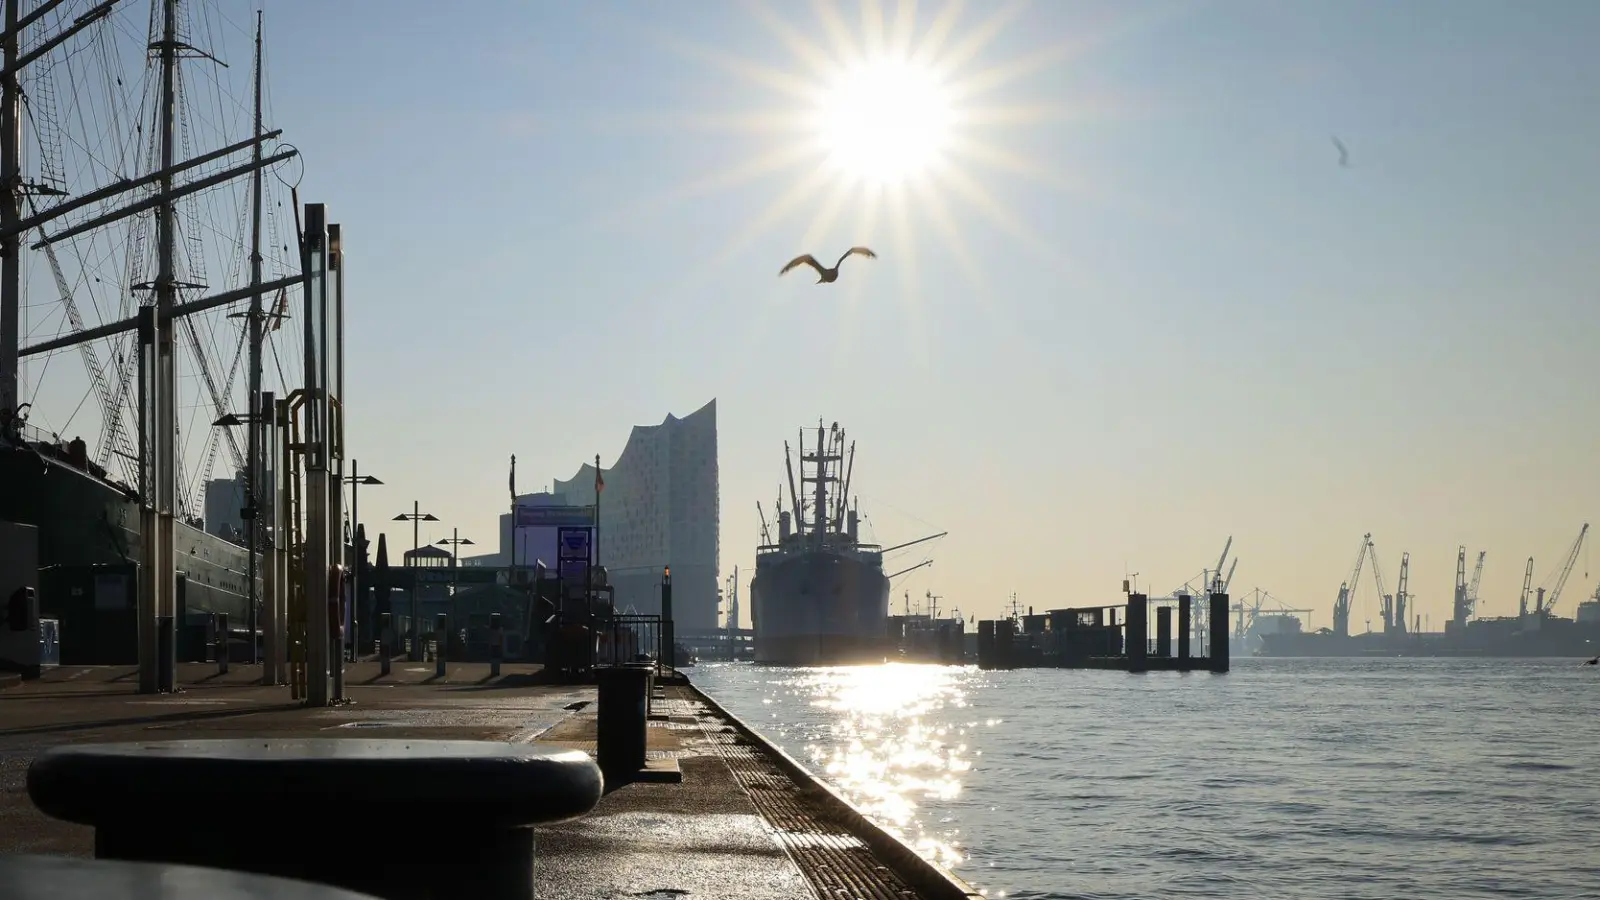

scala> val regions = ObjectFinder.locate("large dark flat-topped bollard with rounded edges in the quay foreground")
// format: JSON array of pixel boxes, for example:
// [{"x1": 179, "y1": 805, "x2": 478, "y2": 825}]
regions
[{"x1": 27, "y1": 738, "x2": 602, "y2": 900}]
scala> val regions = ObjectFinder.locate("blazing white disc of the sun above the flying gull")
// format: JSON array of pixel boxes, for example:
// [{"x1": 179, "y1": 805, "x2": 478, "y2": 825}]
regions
[{"x1": 816, "y1": 59, "x2": 955, "y2": 184}]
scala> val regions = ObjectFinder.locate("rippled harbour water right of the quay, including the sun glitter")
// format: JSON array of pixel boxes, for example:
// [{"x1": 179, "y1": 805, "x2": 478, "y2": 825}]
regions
[{"x1": 693, "y1": 660, "x2": 1600, "y2": 900}]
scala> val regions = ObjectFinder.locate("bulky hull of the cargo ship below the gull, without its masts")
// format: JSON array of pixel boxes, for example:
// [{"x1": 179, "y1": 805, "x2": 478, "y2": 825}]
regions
[{"x1": 750, "y1": 551, "x2": 890, "y2": 666}]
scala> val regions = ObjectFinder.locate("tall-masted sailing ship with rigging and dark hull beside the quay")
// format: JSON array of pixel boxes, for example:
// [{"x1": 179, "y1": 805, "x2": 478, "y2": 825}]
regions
[{"x1": 0, "y1": 0, "x2": 301, "y2": 663}]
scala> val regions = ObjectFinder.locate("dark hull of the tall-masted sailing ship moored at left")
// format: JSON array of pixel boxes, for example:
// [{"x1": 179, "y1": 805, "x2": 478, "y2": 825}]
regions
[{"x1": 0, "y1": 445, "x2": 250, "y2": 665}]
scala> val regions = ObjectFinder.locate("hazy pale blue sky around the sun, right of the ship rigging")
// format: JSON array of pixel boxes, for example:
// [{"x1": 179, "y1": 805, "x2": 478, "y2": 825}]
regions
[{"x1": 18, "y1": 0, "x2": 1600, "y2": 629}]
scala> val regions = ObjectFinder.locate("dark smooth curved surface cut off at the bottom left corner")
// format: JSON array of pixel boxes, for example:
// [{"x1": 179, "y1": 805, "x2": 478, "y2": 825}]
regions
[{"x1": 0, "y1": 855, "x2": 373, "y2": 900}]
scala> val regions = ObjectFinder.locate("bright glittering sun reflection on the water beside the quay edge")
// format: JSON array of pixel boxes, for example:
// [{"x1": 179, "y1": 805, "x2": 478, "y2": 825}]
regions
[{"x1": 786, "y1": 663, "x2": 976, "y2": 866}]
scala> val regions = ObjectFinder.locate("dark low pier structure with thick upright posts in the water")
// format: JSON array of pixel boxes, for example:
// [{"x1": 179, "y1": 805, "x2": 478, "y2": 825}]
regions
[{"x1": 978, "y1": 593, "x2": 1229, "y2": 673}]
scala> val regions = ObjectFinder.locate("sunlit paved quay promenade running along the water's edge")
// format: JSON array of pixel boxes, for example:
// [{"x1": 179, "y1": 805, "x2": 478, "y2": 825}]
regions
[{"x1": 0, "y1": 660, "x2": 966, "y2": 900}]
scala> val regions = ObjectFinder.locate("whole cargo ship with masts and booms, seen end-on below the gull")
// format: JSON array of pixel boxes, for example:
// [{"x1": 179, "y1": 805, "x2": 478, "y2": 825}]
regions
[{"x1": 750, "y1": 423, "x2": 944, "y2": 666}]
